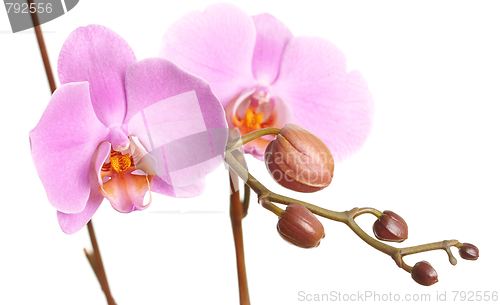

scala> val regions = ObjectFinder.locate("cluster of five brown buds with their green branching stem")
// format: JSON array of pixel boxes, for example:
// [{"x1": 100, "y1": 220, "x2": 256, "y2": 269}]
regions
[{"x1": 254, "y1": 124, "x2": 479, "y2": 286}]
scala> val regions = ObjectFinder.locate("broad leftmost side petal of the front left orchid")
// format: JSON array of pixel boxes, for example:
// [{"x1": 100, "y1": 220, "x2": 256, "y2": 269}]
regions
[{"x1": 30, "y1": 82, "x2": 108, "y2": 213}]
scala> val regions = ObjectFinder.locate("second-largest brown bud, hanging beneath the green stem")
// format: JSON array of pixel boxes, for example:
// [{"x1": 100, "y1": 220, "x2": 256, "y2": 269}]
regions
[{"x1": 277, "y1": 203, "x2": 325, "y2": 248}]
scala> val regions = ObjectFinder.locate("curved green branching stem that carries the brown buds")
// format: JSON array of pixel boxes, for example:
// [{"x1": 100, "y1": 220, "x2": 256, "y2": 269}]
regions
[{"x1": 226, "y1": 138, "x2": 461, "y2": 272}]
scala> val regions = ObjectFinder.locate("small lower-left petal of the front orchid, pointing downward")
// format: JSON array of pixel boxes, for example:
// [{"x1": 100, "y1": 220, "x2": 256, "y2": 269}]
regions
[{"x1": 57, "y1": 189, "x2": 104, "y2": 234}]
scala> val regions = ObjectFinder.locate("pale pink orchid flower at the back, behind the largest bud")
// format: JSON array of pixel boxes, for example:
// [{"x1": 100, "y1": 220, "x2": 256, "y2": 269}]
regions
[{"x1": 160, "y1": 3, "x2": 373, "y2": 161}]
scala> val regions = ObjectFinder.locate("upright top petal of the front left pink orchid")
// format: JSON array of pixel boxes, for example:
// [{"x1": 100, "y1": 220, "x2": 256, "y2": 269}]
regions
[{"x1": 57, "y1": 25, "x2": 136, "y2": 127}]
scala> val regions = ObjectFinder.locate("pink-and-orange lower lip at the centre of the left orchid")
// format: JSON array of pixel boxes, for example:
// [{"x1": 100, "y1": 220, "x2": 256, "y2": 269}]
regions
[{"x1": 101, "y1": 169, "x2": 151, "y2": 213}]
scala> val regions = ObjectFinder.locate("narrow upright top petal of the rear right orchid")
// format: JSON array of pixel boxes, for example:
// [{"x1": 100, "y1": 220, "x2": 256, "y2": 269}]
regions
[{"x1": 252, "y1": 14, "x2": 293, "y2": 86}]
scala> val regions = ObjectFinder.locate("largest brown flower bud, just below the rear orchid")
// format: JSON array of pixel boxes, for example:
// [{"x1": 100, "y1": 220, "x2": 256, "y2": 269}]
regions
[{"x1": 265, "y1": 124, "x2": 334, "y2": 193}]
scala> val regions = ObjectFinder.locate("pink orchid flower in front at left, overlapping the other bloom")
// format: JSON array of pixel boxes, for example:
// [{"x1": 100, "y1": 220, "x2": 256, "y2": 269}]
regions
[{"x1": 30, "y1": 25, "x2": 227, "y2": 234}]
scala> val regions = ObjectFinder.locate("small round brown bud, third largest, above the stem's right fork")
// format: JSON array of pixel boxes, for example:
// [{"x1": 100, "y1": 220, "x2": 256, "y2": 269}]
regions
[{"x1": 373, "y1": 211, "x2": 408, "y2": 243}]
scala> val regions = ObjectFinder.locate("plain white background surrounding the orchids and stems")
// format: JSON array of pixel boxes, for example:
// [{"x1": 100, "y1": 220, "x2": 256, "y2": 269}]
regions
[{"x1": 0, "y1": 0, "x2": 500, "y2": 305}]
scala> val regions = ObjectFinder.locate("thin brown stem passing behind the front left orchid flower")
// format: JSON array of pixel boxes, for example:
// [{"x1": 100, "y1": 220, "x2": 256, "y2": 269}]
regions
[{"x1": 28, "y1": 7, "x2": 116, "y2": 305}]
